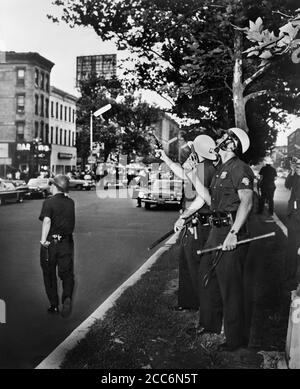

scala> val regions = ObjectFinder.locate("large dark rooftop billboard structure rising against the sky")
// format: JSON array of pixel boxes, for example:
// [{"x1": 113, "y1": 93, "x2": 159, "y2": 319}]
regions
[{"x1": 76, "y1": 54, "x2": 117, "y2": 87}]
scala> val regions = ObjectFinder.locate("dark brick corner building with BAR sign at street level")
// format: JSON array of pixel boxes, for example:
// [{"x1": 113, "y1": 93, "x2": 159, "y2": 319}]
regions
[{"x1": 0, "y1": 51, "x2": 54, "y2": 176}]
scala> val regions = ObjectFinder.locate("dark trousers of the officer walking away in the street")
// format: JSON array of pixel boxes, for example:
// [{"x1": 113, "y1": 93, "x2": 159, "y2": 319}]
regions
[{"x1": 40, "y1": 238, "x2": 74, "y2": 306}]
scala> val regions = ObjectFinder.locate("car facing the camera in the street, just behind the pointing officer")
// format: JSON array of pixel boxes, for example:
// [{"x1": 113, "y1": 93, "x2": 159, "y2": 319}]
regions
[{"x1": 139, "y1": 179, "x2": 183, "y2": 209}]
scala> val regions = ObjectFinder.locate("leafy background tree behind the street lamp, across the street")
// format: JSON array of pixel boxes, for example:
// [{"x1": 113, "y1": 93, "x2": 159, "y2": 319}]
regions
[{"x1": 77, "y1": 74, "x2": 160, "y2": 161}]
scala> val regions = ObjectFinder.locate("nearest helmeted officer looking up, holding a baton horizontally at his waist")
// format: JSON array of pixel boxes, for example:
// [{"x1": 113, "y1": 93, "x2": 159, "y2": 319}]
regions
[{"x1": 200, "y1": 128, "x2": 254, "y2": 351}]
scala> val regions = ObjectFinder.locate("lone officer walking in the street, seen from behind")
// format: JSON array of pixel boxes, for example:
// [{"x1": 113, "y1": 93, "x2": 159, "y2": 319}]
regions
[{"x1": 39, "y1": 174, "x2": 75, "y2": 317}]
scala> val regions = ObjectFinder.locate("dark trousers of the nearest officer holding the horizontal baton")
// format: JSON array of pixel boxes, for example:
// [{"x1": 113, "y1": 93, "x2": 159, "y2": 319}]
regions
[{"x1": 200, "y1": 226, "x2": 251, "y2": 347}]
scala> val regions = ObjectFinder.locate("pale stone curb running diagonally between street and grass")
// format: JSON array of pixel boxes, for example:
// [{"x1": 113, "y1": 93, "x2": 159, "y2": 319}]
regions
[{"x1": 35, "y1": 232, "x2": 179, "y2": 370}]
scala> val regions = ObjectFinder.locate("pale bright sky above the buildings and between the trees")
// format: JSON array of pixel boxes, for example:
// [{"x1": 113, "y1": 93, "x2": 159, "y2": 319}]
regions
[{"x1": 0, "y1": 0, "x2": 300, "y2": 145}]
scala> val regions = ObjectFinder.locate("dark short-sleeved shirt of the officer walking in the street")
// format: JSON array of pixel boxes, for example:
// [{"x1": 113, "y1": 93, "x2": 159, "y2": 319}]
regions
[{"x1": 39, "y1": 193, "x2": 75, "y2": 235}]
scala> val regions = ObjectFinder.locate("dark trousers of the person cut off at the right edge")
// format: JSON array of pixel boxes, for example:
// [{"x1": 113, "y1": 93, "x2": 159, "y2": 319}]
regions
[{"x1": 286, "y1": 212, "x2": 300, "y2": 286}]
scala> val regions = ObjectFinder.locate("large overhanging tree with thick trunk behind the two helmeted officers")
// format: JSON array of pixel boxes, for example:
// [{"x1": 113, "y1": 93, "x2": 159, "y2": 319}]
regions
[{"x1": 48, "y1": 0, "x2": 299, "y2": 160}]
